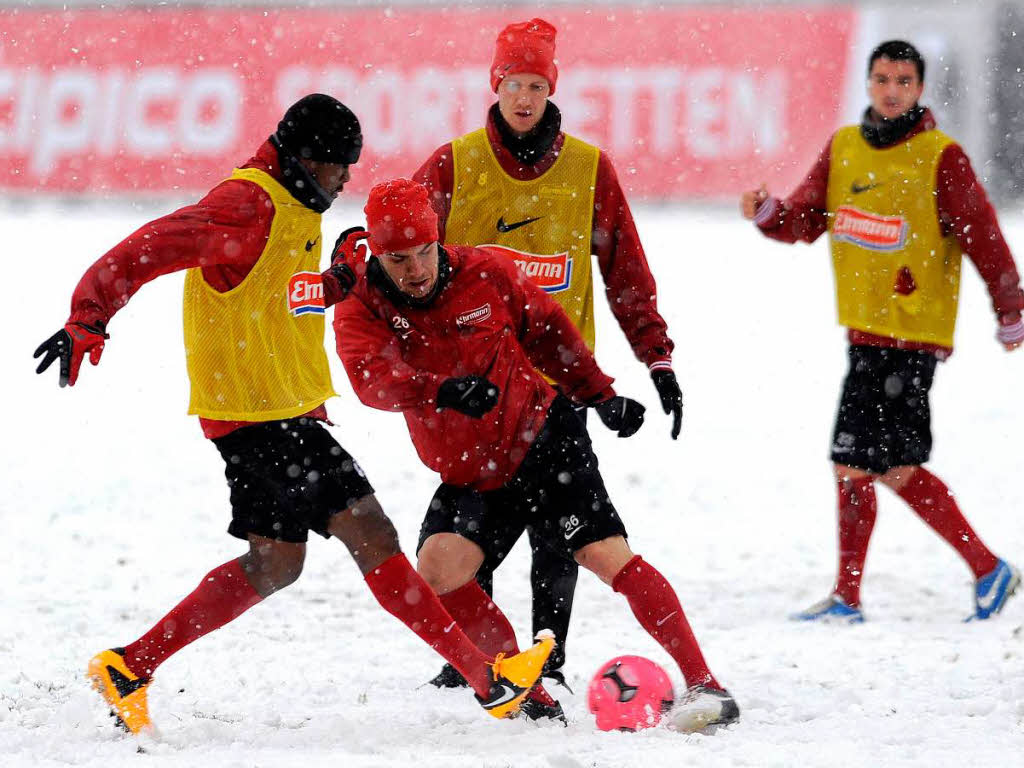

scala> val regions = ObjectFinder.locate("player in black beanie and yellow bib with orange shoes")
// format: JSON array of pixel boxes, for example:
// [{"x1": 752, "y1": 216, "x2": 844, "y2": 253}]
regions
[{"x1": 35, "y1": 93, "x2": 552, "y2": 733}]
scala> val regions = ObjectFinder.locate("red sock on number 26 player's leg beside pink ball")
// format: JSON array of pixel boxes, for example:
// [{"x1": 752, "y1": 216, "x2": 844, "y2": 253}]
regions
[{"x1": 611, "y1": 555, "x2": 722, "y2": 688}]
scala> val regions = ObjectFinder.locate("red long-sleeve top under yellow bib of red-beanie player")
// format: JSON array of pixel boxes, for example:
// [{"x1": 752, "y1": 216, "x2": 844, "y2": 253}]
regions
[{"x1": 414, "y1": 109, "x2": 674, "y2": 368}]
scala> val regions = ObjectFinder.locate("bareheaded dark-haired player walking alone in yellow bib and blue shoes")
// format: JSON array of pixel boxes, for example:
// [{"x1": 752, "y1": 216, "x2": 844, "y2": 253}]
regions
[{"x1": 741, "y1": 40, "x2": 1024, "y2": 622}]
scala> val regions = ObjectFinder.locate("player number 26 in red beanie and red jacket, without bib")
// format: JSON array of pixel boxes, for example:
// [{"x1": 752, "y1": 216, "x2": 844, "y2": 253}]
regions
[{"x1": 334, "y1": 179, "x2": 739, "y2": 731}]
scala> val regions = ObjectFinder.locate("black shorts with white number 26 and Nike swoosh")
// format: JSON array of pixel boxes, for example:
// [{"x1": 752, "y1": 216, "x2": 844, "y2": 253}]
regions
[{"x1": 417, "y1": 396, "x2": 627, "y2": 565}]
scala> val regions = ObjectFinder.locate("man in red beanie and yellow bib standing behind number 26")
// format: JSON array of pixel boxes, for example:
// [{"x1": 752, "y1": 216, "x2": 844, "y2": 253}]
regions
[{"x1": 414, "y1": 18, "x2": 683, "y2": 708}]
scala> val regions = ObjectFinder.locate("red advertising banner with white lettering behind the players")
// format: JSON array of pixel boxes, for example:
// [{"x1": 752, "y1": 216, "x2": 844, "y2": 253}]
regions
[{"x1": 0, "y1": 6, "x2": 855, "y2": 200}]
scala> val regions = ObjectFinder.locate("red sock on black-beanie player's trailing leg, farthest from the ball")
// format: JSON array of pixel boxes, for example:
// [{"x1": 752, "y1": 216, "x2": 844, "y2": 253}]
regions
[{"x1": 125, "y1": 560, "x2": 263, "y2": 677}]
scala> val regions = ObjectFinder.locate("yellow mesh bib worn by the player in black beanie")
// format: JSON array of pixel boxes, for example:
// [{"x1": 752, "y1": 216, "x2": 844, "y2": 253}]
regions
[{"x1": 184, "y1": 168, "x2": 335, "y2": 421}]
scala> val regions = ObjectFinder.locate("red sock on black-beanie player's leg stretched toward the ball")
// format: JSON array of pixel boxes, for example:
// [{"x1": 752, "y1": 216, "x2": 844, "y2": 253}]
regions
[{"x1": 366, "y1": 553, "x2": 493, "y2": 696}]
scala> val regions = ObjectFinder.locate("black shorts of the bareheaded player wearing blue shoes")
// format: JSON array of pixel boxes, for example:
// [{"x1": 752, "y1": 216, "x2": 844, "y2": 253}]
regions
[{"x1": 831, "y1": 345, "x2": 937, "y2": 474}]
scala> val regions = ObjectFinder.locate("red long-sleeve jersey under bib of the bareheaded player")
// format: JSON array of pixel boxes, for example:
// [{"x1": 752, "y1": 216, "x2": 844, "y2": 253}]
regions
[{"x1": 755, "y1": 110, "x2": 1024, "y2": 356}]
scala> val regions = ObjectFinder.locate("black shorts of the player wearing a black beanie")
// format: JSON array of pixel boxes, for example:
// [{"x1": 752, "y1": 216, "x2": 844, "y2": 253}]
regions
[{"x1": 213, "y1": 417, "x2": 374, "y2": 543}]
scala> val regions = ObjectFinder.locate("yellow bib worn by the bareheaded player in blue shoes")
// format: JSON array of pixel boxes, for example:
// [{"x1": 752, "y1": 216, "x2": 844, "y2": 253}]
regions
[{"x1": 827, "y1": 126, "x2": 962, "y2": 347}]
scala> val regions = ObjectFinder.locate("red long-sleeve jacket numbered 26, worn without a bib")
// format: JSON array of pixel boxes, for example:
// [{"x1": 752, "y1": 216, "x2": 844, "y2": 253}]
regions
[{"x1": 334, "y1": 246, "x2": 614, "y2": 490}]
